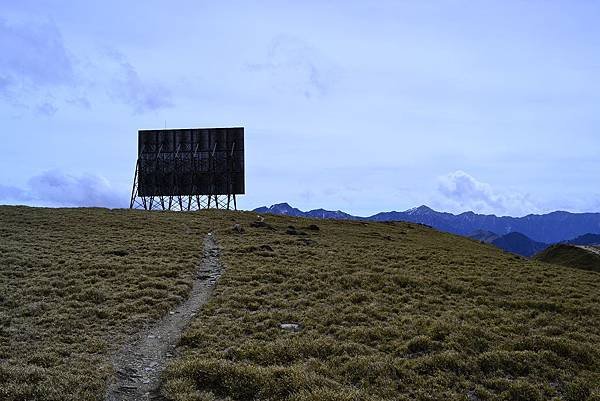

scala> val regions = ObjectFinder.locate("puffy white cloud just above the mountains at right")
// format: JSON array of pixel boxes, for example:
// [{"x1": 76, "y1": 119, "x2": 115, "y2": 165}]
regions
[{"x1": 438, "y1": 170, "x2": 540, "y2": 215}]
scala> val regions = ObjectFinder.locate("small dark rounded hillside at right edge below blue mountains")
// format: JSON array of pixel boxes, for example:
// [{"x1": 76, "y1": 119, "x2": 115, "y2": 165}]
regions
[{"x1": 535, "y1": 244, "x2": 600, "y2": 272}]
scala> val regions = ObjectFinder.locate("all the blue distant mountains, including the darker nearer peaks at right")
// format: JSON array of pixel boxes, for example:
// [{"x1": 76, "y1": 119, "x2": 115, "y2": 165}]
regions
[{"x1": 254, "y1": 203, "x2": 600, "y2": 257}]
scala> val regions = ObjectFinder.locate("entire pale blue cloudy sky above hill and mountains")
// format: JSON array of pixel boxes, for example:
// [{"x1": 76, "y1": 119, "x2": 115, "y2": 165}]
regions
[{"x1": 0, "y1": 0, "x2": 600, "y2": 216}]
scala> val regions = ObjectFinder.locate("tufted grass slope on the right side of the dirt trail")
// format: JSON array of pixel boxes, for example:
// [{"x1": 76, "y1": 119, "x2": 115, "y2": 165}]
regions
[{"x1": 164, "y1": 214, "x2": 600, "y2": 401}]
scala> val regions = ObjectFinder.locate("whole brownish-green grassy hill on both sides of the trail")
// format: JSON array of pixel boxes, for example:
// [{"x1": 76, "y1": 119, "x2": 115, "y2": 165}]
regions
[{"x1": 0, "y1": 207, "x2": 600, "y2": 401}]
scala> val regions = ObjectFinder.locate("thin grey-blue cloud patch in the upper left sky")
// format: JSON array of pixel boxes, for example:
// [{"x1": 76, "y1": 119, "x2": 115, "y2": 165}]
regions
[{"x1": 0, "y1": 19, "x2": 173, "y2": 117}]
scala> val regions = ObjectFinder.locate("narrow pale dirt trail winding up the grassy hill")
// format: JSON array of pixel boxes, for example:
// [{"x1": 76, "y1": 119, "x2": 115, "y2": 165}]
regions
[{"x1": 105, "y1": 234, "x2": 222, "y2": 401}]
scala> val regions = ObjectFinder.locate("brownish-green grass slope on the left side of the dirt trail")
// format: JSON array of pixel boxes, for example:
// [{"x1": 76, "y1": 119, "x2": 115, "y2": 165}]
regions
[{"x1": 0, "y1": 207, "x2": 232, "y2": 401}]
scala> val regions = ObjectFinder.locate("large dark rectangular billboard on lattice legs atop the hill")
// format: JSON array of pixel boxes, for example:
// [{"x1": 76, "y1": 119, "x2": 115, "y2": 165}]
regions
[{"x1": 129, "y1": 127, "x2": 245, "y2": 211}]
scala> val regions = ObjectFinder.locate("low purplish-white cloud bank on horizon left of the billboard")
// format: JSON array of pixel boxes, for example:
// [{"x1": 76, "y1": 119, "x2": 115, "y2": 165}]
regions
[{"x1": 0, "y1": 170, "x2": 128, "y2": 208}]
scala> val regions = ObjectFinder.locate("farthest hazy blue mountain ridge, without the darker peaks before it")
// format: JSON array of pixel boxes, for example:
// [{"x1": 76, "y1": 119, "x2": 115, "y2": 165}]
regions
[{"x1": 256, "y1": 203, "x2": 600, "y2": 244}]
